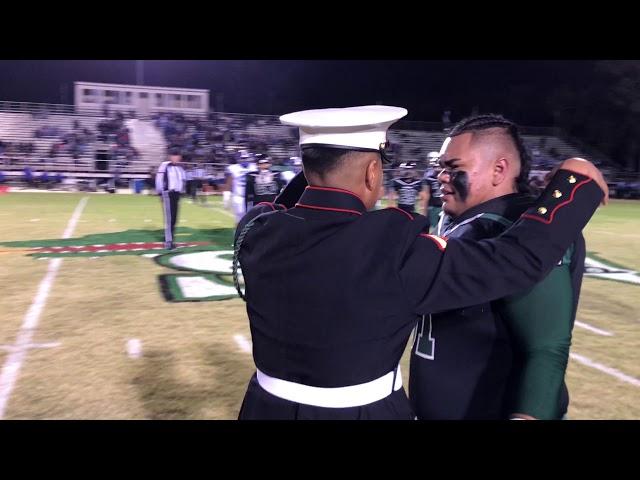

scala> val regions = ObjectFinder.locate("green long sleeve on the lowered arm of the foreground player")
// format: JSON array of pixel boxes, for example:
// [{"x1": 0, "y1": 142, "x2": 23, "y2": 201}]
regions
[{"x1": 499, "y1": 264, "x2": 573, "y2": 420}]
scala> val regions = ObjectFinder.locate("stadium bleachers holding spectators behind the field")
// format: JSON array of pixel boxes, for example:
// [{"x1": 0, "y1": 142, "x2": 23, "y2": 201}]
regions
[{"x1": 0, "y1": 102, "x2": 632, "y2": 195}]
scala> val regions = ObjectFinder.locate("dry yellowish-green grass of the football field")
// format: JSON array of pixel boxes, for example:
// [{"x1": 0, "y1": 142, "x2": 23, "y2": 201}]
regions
[{"x1": 0, "y1": 189, "x2": 640, "y2": 419}]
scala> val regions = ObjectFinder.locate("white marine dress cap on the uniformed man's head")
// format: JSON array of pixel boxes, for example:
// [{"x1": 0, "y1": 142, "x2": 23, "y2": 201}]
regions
[{"x1": 280, "y1": 105, "x2": 408, "y2": 151}]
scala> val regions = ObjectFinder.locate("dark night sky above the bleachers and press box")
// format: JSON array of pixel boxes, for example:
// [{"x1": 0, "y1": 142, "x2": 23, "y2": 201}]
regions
[{"x1": 0, "y1": 60, "x2": 593, "y2": 126}]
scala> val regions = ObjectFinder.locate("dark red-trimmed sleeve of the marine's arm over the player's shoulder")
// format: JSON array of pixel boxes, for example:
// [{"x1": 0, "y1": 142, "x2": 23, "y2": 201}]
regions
[{"x1": 399, "y1": 170, "x2": 603, "y2": 314}]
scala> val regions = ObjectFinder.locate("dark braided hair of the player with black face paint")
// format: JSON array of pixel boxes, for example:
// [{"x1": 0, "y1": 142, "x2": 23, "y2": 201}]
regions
[{"x1": 448, "y1": 113, "x2": 531, "y2": 193}]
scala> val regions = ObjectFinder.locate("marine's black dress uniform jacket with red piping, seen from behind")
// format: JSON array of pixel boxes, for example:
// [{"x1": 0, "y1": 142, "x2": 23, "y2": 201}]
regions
[{"x1": 236, "y1": 170, "x2": 603, "y2": 419}]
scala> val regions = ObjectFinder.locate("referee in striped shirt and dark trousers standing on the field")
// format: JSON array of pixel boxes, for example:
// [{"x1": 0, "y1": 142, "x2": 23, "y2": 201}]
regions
[{"x1": 156, "y1": 148, "x2": 186, "y2": 250}]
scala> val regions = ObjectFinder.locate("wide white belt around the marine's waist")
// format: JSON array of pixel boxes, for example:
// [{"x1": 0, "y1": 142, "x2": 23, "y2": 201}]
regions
[{"x1": 257, "y1": 365, "x2": 402, "y2": 408}]
